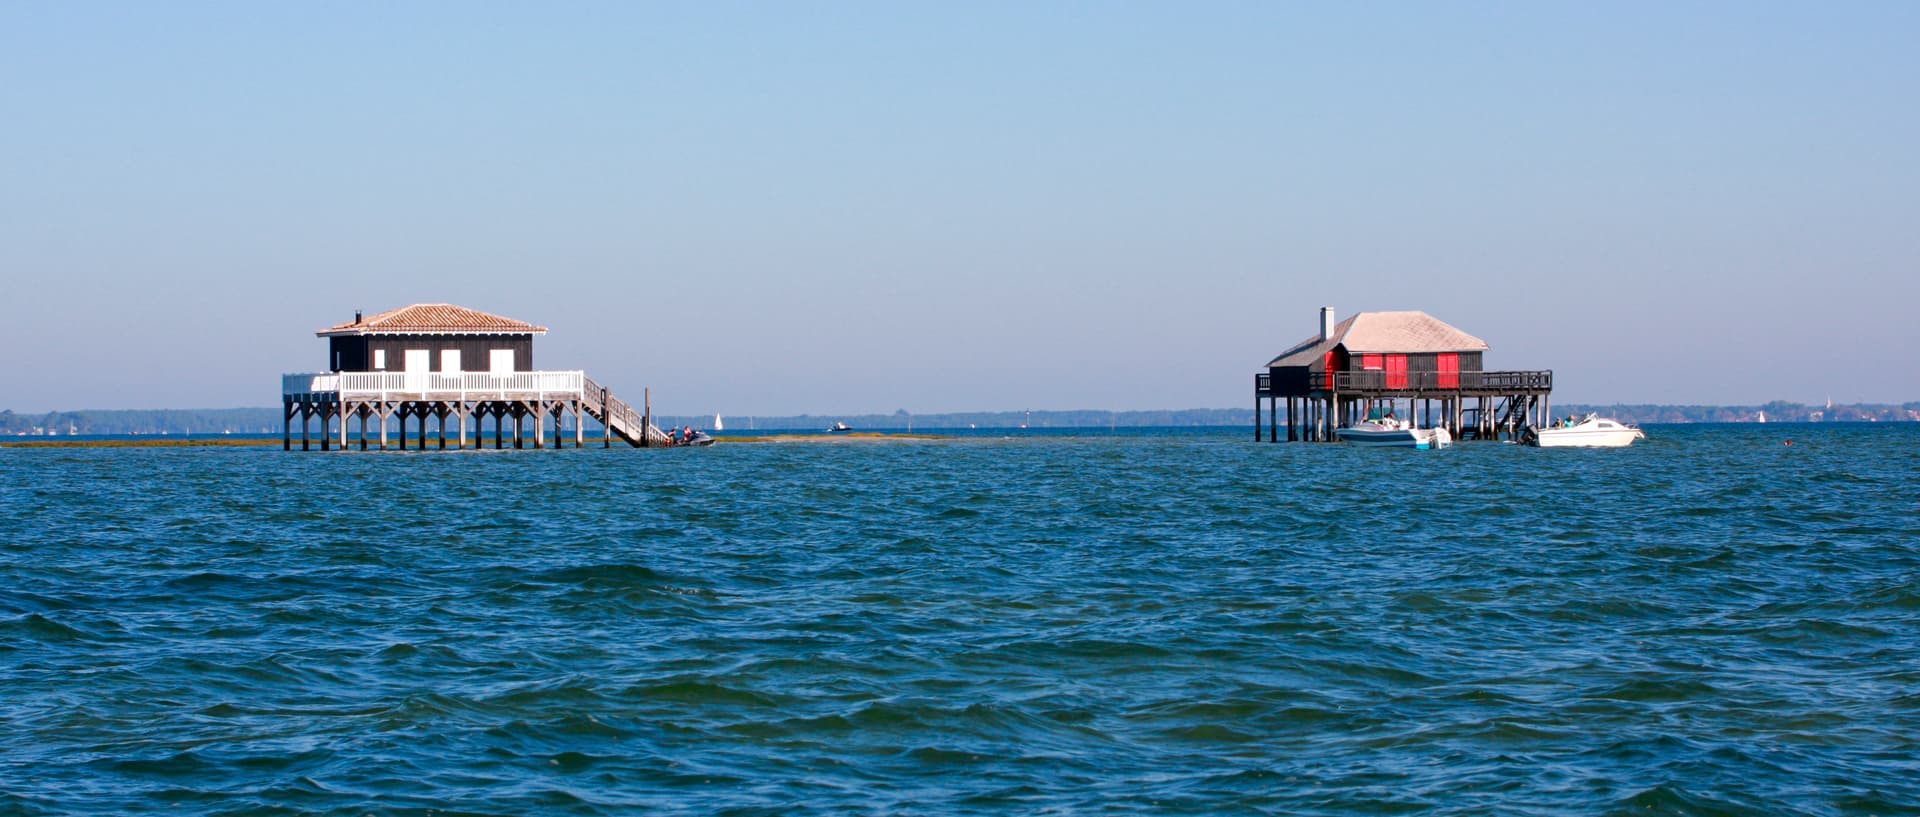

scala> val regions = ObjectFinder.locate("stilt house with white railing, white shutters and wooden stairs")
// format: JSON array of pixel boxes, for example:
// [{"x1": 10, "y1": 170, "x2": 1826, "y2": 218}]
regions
[{"x1": 280, "y1": 303, "x2": 666, "y2": 451}]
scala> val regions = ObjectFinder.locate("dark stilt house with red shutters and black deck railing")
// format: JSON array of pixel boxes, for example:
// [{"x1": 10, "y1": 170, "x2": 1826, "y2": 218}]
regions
[{"x1": 1254, "y1": 307, "x2": 1553, "y2": 441}]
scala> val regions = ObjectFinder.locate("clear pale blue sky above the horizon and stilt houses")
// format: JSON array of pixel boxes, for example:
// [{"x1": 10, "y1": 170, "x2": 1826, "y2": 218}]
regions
[{"x1": 0, "y1": 0, "x2": 1920, "y2": 414}]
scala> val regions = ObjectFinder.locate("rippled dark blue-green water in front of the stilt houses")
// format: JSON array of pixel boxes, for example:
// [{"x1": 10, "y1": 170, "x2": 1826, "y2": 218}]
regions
[{"x1": 0, "y1": 426, "x2": 1920, "y2": 815}]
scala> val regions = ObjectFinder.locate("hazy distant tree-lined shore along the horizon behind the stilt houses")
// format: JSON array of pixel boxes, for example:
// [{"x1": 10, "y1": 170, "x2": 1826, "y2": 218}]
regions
[{"x1": 0, "y1": 401, "x2": 1920, "y2": 435}]
